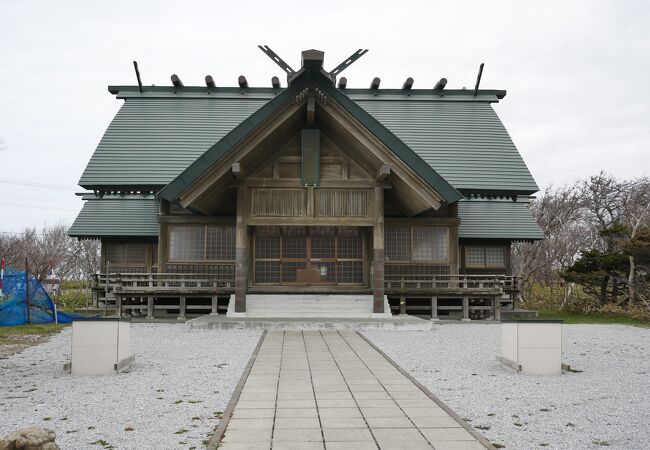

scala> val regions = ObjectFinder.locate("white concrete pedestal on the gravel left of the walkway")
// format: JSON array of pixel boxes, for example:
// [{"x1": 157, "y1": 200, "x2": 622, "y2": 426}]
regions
[{"x1": 70, "y1": 319, "x2": 134, "y2": 375}]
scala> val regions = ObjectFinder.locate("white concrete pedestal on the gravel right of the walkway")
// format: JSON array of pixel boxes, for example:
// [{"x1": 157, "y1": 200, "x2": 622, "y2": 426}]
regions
[{"x1": 499, "y1": 320, "x2": 562, "y2": 375}]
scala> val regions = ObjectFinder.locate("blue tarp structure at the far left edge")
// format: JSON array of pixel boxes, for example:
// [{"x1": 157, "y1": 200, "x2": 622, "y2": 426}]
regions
[{"x1": 0, "y1": 268, "x2": 90, "y2": 325}]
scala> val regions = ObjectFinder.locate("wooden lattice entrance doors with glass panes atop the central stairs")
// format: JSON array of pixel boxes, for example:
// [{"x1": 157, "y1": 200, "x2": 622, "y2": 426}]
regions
[{"x1": 253, "y1": 227, "x2": 365, "y2": 286}]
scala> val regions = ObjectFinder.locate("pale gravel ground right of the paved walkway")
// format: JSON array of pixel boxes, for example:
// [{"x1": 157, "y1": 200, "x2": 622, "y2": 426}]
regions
[{"x1": 364, "y1": 324, "x2": 650, "y2": 450}]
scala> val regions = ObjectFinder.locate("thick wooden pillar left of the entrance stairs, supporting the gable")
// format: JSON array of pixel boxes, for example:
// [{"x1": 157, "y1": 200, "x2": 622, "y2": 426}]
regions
[{"x1": 235, "y1": 187, "x2": 249, "y2": 313}]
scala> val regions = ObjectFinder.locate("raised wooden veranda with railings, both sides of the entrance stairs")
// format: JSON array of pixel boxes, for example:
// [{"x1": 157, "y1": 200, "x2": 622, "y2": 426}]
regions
[{"x1": 93, "y1": 273, "x2": 519, "y2": 320}]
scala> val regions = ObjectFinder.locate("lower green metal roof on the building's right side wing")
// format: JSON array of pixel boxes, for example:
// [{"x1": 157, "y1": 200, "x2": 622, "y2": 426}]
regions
[{"x1": 458, "y1": 199, "x2": 544, "y2": 241}]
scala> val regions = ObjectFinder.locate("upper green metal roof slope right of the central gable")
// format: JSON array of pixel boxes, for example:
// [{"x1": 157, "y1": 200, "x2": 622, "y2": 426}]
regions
[{"x1": 351, "y1": 95, "x2": 539, "y2": 194}]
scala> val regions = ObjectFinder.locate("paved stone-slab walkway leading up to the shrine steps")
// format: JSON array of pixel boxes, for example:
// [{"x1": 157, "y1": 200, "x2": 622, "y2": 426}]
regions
[{"x1": 219, "y1": 331, "x2": 486, "y2": 450}]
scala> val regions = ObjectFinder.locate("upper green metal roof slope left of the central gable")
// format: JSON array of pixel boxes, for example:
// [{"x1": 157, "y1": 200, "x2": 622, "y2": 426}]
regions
[{"x1": 79, "y1": 95, "x2": 270, "y2": 189}]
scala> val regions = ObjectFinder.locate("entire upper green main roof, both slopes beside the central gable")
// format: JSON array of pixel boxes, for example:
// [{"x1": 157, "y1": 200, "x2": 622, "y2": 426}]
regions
[{"x1": 79, "y1": 80, "x2": 539, "y2": 194}]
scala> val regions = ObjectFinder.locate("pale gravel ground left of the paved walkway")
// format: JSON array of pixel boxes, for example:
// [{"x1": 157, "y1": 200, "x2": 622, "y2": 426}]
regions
[{"x1": 0, "y1": 324, "x2": 261, "y2": 450}]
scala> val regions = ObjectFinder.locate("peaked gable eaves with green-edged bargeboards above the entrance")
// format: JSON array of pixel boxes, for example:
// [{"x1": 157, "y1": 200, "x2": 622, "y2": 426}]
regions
[{"x1": 159, "y1": 71, "x2": 462, "y2": 216}]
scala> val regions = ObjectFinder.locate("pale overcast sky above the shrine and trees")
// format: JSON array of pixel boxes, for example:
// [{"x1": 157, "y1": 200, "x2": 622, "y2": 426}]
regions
[{"x1": 0, "y1": 0, "x2": 650, "y2": 232}]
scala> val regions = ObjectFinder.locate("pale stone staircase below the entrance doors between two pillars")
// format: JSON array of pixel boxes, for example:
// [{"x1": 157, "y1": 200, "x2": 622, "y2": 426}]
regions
[{"x1": 227, "y1": 294, "x2": 391, "y2": 319}]
